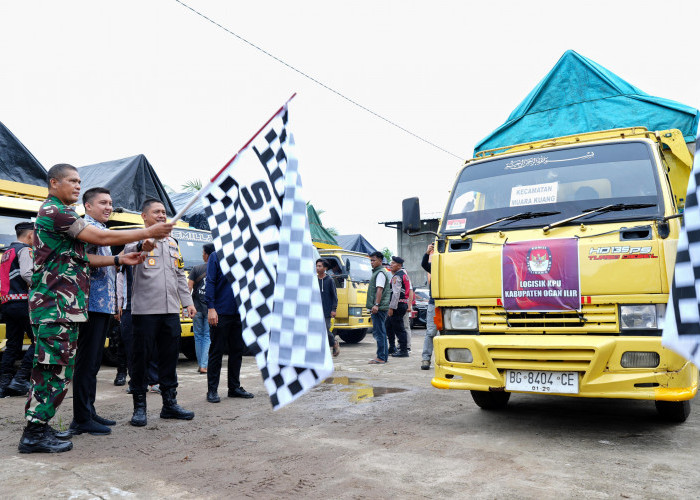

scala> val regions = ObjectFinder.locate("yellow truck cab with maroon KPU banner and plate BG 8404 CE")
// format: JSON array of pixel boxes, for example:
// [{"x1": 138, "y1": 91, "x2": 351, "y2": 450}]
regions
[{"x1": 403, "y1": 127, "x2": 698, "y2": 421}]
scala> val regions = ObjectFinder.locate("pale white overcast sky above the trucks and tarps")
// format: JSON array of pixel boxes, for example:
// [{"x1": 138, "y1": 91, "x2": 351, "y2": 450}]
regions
[{"x1": 0, "y1": 0, "x2": 700, "y2": 250}]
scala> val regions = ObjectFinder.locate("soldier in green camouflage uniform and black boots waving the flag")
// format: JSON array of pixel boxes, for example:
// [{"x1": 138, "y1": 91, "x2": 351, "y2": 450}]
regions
[{"x1": 19, "y1": 164, "x2": 172, "y2": 453}]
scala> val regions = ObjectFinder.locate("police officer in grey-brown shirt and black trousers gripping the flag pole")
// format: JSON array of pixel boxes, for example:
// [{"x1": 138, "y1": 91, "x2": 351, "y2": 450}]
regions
[{"x1": 124, "y1": 199, "x2": 197, "y2": 427}]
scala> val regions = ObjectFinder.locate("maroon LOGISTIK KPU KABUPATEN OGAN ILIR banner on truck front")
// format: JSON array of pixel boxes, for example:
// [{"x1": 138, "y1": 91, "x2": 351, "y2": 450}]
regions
[{"x1": 502, "y1": 238, "x2": 581, "y2": 312}]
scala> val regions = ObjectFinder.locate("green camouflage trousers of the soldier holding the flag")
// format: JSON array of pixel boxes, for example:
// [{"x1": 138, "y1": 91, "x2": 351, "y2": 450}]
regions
[{"x1": 24, "y1": 323, "x2": 79, "y2": 423}]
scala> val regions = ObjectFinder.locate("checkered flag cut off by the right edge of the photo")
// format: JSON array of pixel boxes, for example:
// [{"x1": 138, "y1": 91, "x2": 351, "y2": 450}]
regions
[{"x1": 661, "y1": 136, "x2": 700, "y2": 366}]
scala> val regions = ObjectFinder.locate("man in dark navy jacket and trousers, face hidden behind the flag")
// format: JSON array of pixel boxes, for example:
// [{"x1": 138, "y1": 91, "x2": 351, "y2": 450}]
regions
[{"x1": 206, "y1": 252, "x2": 253, "y2": 403}]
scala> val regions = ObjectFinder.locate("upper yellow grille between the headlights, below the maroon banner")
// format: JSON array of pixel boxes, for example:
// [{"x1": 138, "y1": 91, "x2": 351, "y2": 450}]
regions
[{"x1": 479, "y1": 304, "x2": 620, "y2": 334}]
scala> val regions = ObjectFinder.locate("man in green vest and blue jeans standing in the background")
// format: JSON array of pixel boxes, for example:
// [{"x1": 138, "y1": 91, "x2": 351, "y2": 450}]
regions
[{"x1": 367, "y1": 252, "x2": 391, "y2": 365}]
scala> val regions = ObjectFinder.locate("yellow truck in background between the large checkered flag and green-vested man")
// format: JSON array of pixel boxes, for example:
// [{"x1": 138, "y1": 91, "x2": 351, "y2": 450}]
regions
[{"x1": 315, "y1": 247, "x2": 372, "y2": 344}]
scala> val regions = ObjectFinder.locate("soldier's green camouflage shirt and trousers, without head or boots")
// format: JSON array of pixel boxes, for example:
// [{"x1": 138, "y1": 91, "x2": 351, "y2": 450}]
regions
[{"x1": 25, "y1": 196, "x2": 90, "y2": 423}]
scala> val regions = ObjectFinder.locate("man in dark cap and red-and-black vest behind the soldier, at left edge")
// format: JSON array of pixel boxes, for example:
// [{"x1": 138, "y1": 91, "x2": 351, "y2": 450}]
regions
[{"x1": 0, "y1": 222, "x2": 34, "y2": 398}]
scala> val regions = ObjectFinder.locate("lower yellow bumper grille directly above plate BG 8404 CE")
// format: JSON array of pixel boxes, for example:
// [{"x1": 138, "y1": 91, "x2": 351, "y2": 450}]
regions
[{"x1": 489, "y1": 347, "x2": 595, "y2": 372}]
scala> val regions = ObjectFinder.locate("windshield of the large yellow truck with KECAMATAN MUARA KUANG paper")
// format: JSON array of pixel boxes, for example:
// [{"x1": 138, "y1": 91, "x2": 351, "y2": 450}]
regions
[{"x1": 443, "y1": 141, "x2": 663, "y2": 232}]
